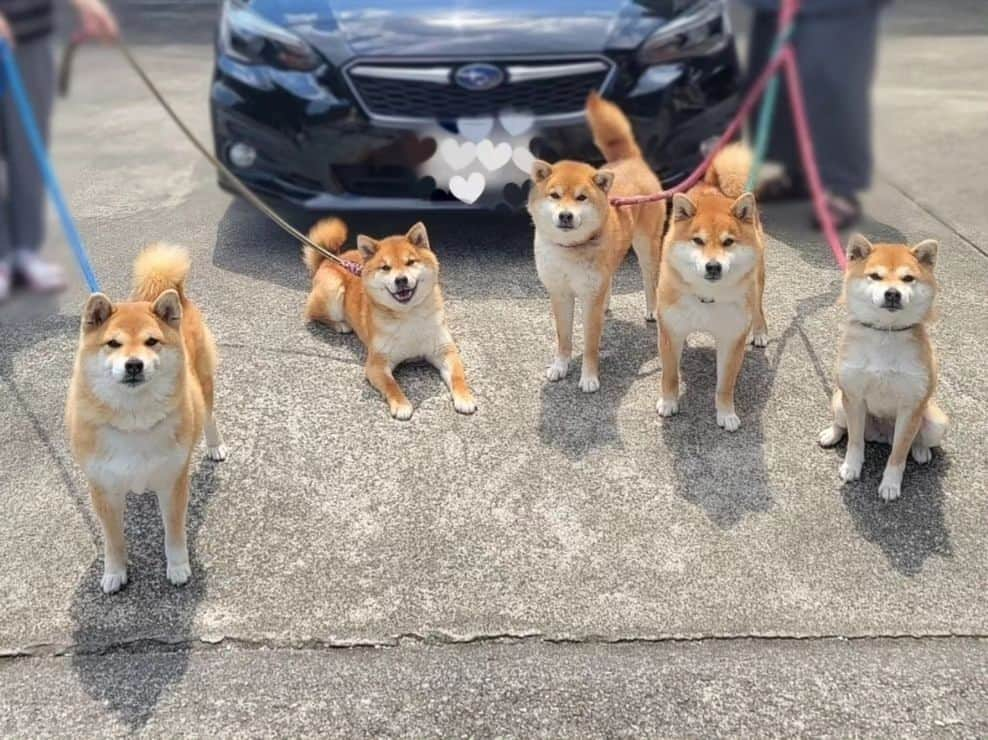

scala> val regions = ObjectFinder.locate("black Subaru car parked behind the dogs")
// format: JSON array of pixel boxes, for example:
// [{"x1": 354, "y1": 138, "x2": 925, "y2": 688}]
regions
[{"x1": 210, "y1": 0, "x2": 740, "y2": 211}]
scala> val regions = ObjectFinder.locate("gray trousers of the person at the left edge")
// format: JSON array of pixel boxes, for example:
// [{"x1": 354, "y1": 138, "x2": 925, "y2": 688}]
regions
[{"x1": 0, "y1": 39, "x2": 55, "y2": 259}]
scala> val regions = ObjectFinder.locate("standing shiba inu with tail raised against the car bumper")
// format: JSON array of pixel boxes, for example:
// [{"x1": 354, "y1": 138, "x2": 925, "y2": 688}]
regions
[{"x1": 528, "y1": 93, "x2": 666, "y2": 393}]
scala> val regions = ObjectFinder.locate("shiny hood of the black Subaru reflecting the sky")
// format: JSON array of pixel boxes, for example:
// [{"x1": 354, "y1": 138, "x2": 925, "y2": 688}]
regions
[{"x1": 266, "y1": 0, "x2": 691, "y2": 62}]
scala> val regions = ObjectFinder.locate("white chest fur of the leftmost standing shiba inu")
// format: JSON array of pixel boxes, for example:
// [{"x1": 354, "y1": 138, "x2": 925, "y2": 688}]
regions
[{"x1": 86, "y1": 413, "x2": 191, "y2": 495}]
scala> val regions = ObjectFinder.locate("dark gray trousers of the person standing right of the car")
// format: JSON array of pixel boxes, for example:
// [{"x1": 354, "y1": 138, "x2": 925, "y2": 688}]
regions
[{"x1": 752, "y1": 5, "x2": 879, "y2": 195}]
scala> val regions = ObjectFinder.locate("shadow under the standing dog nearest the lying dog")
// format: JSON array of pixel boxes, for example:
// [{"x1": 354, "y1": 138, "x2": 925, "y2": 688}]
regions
[{"x1": 538, "y1": 317, "x2": 656, "y2": 460}]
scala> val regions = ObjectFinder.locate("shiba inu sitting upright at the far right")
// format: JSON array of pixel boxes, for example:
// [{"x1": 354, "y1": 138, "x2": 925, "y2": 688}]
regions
[{"x1": 819, "y1": 234, "x2": 947, "y2": 501}]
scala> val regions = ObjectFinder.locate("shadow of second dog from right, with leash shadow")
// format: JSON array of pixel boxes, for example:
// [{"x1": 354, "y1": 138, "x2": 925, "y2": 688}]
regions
[{"x1": 661, "y1": 281, "x2": 840, "y2": 529}]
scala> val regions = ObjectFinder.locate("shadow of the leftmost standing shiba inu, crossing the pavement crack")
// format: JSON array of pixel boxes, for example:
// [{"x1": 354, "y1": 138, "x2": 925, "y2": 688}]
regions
[{"x1": 70, "y1": 460, "x2": 222, "y2": 732}]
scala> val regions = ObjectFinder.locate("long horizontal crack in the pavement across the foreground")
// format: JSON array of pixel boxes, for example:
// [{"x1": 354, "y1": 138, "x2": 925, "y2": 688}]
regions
[{"x1": 0, "y1": 631, "x2": 988, "y2": 666}]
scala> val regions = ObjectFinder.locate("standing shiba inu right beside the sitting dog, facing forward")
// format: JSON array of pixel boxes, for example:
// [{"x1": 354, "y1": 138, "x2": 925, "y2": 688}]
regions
[{"x1": 657, "y1": 145, "x2": 768, "y2": 432}]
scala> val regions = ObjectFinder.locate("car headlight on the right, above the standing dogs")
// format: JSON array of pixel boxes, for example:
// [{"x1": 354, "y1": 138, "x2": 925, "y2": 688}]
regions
[{"x1": 638, "y1": 0, "x2": 730, "y2": 65}]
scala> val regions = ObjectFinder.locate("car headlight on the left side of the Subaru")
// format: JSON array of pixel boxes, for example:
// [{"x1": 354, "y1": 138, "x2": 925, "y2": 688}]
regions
[{"x1": 219, "y1": 0, "x2": 321, "y2": 72}]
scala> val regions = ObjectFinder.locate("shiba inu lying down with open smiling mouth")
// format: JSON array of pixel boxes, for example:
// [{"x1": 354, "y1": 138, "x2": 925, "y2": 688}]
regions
[{"x1": 303, "y1": 219, "x2": 477, "y2": 420}]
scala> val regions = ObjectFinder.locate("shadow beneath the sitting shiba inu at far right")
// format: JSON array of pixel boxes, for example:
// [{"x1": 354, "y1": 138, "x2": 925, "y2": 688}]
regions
[{"x1": 833, "y1": 442, "x2": 953, "y2": 576}]
